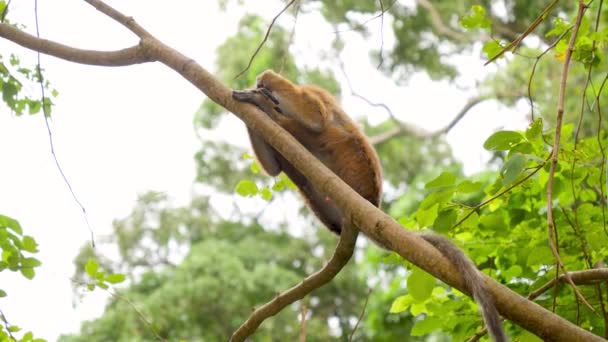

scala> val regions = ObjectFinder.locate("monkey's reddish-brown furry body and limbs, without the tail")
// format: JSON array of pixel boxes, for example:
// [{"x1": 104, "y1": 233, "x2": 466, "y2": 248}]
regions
[{"x1": 234, "y1": 70, "x2": 382, "y2": 234}]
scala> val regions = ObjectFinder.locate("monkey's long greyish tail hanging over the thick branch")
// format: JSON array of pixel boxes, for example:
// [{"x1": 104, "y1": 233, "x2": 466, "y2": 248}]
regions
[{"x1": 421, "y1": 233, "x2": 508, "y2": 342}]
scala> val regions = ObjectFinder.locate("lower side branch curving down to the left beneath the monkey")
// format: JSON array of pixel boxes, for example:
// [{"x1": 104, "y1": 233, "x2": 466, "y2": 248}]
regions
[{"x1": 230, "y1": 225, "x2": 359, "y2": 342}]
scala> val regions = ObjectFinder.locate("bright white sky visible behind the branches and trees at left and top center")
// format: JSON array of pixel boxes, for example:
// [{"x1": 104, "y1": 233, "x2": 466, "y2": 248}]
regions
[{"x1": 0, "y1": 0, "x2": 525, "y2": 341}]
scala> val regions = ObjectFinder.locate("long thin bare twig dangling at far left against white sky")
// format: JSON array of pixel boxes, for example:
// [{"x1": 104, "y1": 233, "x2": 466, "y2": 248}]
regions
[{"x1": 34, "y1": 0, "x2": 95, "y2": 248}]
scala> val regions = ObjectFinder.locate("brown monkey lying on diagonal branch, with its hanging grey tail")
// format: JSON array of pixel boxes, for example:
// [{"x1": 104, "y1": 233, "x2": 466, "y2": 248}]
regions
[{"x1": 232, "y1": 70, "x2": 507, "y2": 342}]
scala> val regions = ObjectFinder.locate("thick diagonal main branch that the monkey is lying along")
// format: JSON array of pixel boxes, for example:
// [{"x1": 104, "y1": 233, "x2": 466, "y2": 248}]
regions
[{"x1": 1, "y1": 0, "x2": 603, "y2": 341}]
